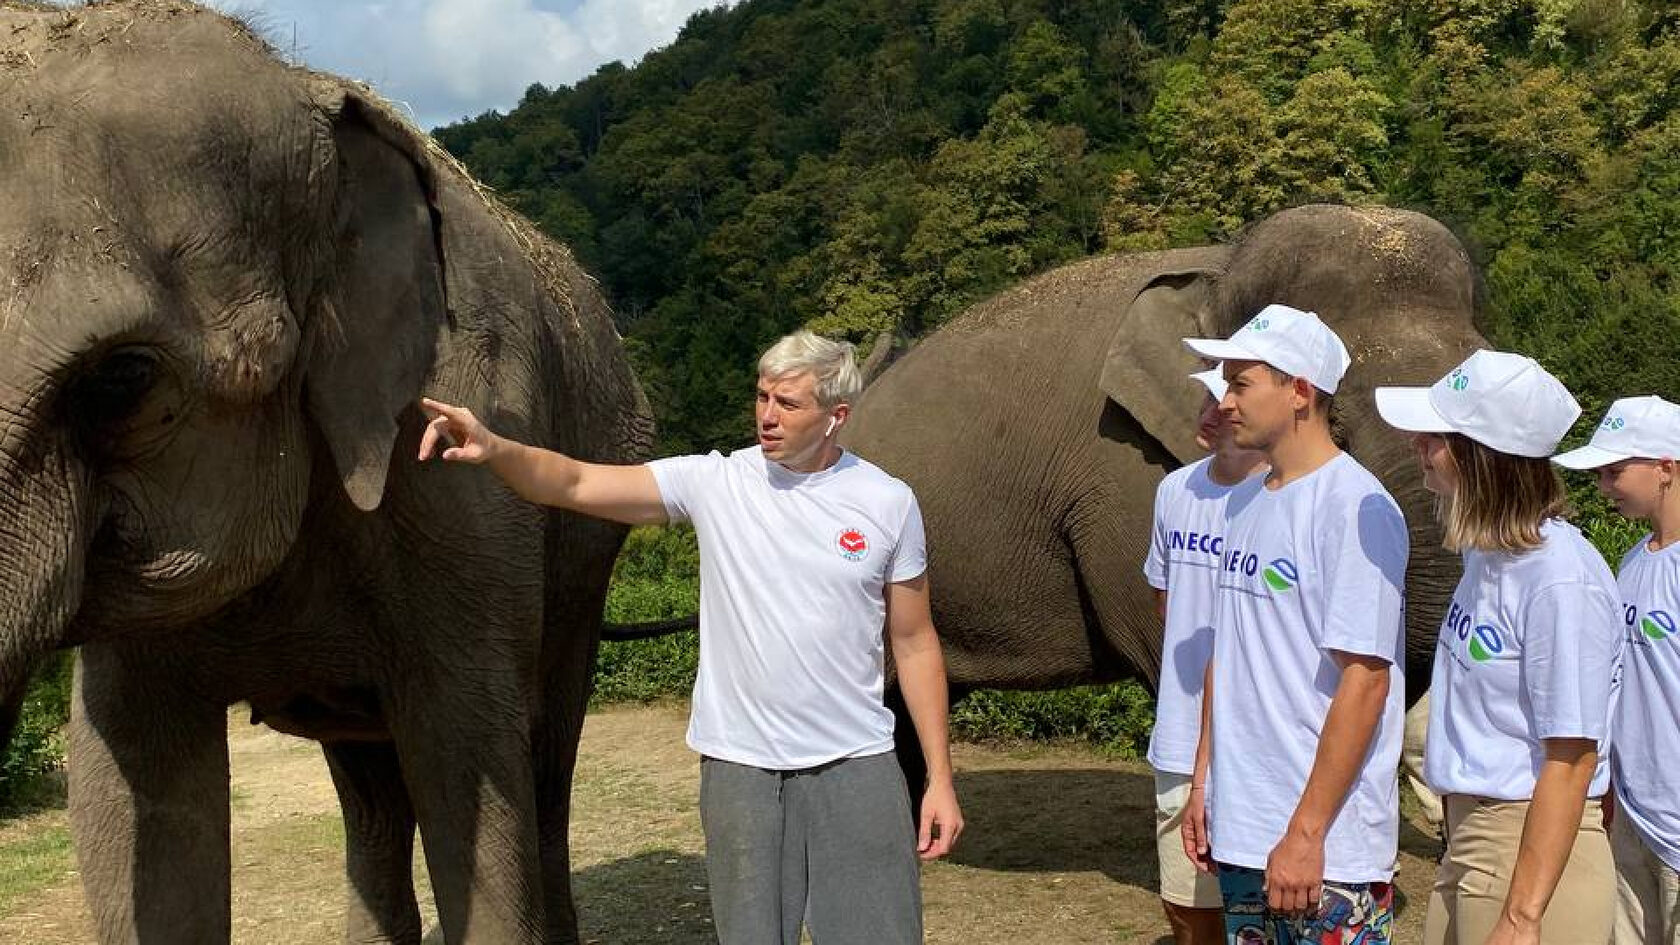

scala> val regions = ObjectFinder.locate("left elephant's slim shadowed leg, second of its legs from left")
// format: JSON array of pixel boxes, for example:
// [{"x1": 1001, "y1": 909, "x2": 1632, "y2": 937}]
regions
[{"x1": 321, "y1": 742, "x2": 420, "y2": 945}]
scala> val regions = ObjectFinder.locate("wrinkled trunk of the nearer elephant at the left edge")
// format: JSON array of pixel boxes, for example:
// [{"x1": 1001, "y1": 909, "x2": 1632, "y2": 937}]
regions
[{"x1": 0, "y1": 446, "x2": 91, "y2": 747}]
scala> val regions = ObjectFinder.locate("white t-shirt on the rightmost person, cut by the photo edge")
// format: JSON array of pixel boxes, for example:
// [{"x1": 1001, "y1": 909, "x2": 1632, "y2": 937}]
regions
[{"x1": 1609, "y1": 535, "x2": 1680, "y2": 869}]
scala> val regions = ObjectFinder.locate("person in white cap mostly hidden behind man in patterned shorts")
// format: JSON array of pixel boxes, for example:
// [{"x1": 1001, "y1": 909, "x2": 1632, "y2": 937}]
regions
[{"x1": 1144, "y1": 367, "x2": 1265, "y2": 945}]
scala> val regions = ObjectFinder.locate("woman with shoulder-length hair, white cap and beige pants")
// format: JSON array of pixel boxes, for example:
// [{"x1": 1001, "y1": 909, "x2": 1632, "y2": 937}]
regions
[{"x1": 1376, "y1": 351, "x2": 1621, "y2": 945}]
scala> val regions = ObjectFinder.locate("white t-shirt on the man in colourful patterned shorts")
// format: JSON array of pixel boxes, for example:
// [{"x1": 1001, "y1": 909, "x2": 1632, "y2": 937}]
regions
[{"x1": 1208, "y1": 452, "x2": 1410, "y2": 883}]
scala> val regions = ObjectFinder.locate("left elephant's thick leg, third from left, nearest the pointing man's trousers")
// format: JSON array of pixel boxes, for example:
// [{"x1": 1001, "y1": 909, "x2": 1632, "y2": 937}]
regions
[{"x1": 390, "y1": 679, "x2": 544, "y2": 945}]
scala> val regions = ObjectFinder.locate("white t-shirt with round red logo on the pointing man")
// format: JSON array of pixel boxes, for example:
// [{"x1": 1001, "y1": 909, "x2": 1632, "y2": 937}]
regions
[{"x1": 648, "y1": 446, "x2": 927, "y2": 770}]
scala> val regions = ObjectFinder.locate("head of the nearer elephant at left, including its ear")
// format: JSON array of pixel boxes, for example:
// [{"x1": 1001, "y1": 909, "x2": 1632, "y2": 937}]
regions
[{"x1": 0, "y1": 2, "x2": 447, "y2": 735}]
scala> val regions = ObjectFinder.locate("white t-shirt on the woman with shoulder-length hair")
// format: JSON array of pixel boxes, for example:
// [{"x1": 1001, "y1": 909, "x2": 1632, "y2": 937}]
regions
[{"x1": 1423, "y1": 520, "x2": 1621, "y2": 800}]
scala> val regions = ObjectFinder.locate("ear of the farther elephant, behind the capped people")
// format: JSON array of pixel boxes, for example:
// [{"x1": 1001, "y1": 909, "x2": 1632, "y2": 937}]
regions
[{"x1": 1097, "y1": 266, "x2": 1216, "y2": 462}]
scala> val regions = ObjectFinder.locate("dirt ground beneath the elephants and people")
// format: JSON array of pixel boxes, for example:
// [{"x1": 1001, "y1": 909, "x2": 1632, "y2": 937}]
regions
[{"x1": 0, "y1": 703, "x2": 1438, "y2": 945}]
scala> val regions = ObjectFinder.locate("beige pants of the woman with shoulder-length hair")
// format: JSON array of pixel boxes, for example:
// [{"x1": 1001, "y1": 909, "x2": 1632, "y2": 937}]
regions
[{"x1": 1423, "y1": 794, "x2": 1616, "y2": 945}]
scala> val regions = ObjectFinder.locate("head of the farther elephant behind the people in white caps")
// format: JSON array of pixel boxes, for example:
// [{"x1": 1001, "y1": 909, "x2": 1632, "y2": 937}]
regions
[{"x1": 1099, "y1": 205, "x2": 1487, "y2": 694}]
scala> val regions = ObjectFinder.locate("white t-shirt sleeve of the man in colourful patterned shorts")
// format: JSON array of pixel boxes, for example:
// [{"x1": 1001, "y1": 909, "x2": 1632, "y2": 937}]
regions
[{"x1": 1319, "y1": 493, "x2": 1411, "y2": 663}]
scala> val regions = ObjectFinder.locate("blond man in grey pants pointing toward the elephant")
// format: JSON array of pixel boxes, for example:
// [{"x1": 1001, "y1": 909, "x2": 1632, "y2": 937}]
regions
[{"x1": 420, "y1": 331, "x2": 963, "y2": 945}]
